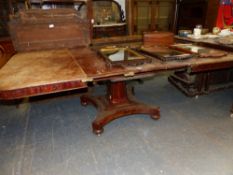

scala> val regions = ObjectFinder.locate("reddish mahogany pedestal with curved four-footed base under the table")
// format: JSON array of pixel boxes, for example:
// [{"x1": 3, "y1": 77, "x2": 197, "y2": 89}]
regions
[{"x1": 81, "y1": 81, "x2": 160, "y2": 135}]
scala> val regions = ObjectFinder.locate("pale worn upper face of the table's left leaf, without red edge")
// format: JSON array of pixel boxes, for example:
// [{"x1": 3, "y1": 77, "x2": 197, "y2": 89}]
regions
[{"x1": 0, "y1": 49, "x2": 87, "y2": 94}]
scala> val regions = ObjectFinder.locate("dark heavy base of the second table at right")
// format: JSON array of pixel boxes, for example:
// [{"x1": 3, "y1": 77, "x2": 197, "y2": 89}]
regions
[{"x1": 168, "y1": 68, "x2": 233, "y2": 97}]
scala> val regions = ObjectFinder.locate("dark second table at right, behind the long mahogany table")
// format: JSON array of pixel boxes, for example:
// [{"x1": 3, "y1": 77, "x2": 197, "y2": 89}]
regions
[{"x1": 168, "y1": 37, "x2": 233, "y2": 96}]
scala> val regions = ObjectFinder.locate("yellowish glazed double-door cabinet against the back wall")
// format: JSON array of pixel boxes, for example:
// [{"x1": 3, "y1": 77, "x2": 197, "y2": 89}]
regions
[{"x1": 130, "y1": 0, "x2": 175, "y2": 34}]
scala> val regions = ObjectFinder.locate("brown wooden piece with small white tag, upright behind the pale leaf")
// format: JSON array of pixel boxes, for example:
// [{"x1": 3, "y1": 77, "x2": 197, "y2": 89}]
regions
[{"x1": 9, "y1": 8, "x2": 90, "y2": 51}]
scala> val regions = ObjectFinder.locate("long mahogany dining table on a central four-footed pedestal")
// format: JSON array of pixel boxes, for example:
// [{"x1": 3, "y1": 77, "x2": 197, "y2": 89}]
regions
[{"x1": 0, "y1": 44, "x2": 233, "y2": 135}]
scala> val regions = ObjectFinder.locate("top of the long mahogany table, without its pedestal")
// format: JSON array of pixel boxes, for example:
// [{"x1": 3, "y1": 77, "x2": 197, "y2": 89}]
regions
[{"x1": 0, "y1": 47, "x2": 233, "y2": 99}]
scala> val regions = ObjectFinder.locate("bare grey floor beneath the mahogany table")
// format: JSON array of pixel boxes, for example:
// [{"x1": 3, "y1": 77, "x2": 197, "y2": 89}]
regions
[{"x1": 0, "y1": 76, "x2": 233, "y2": 175}]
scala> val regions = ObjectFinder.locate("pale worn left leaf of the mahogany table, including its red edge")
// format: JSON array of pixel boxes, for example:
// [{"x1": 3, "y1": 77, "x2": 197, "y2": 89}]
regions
[{"x1": 0, "y1": 49, "x2": 87, "y2": 99}]
